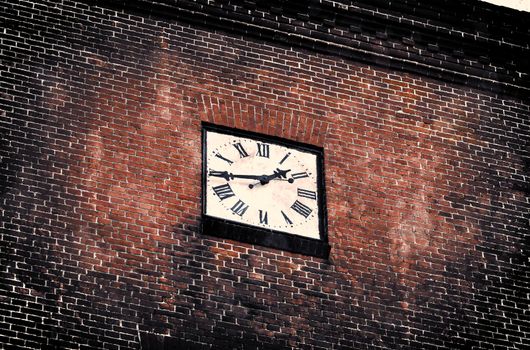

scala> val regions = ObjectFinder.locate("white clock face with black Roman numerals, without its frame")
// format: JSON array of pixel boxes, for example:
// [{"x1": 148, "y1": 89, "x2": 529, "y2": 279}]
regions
[{"x1": 205, "y1": 131, "x2": 320, "y2": 239}]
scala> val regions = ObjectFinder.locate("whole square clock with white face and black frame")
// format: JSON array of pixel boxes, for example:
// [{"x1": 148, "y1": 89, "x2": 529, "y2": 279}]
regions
[{"x1": 202, "y1": 123, "x2": 329, "y2": 258}]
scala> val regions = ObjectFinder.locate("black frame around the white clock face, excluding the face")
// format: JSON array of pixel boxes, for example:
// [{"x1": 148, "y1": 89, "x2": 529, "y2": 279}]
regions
[{"x1": 201, "y1": 122, "x2": 330, "y2": 259}]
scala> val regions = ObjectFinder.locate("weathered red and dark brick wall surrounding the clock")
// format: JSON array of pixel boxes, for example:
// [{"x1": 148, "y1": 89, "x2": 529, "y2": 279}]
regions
[{"x1": 0, "y1": 0, "x2": 530, "y2": 349}]
